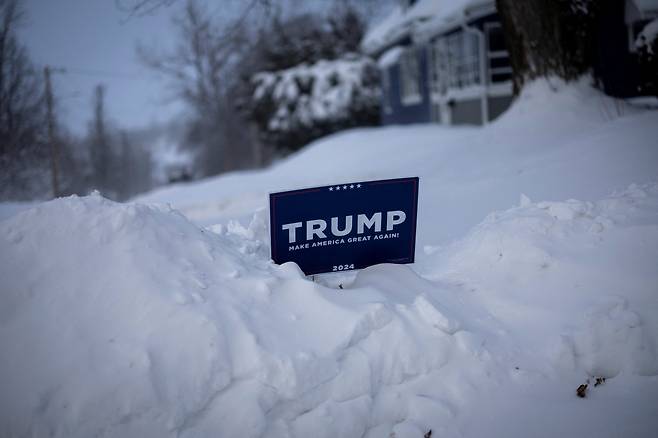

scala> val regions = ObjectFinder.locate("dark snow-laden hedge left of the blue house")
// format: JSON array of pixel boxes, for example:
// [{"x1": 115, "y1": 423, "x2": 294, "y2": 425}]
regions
[{"x1": 251, "y1": 54, "x2": 380, "y2": 150}]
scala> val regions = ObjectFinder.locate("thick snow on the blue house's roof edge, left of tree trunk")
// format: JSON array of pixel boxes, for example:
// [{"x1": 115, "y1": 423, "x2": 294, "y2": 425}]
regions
[{"x1": 361, "y1": 0, "x2": 494, "y2": 54}]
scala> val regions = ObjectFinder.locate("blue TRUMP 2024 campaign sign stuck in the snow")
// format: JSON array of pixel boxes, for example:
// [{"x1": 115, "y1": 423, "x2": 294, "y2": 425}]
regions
[{"x1": 270, "y1": 177, "x2": 418, "y2": 275}]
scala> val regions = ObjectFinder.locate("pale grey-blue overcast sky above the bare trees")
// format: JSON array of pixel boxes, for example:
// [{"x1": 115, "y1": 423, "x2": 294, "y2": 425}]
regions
[{"x1": 22, "y1": 0, "x2": 390, "y2": 134}]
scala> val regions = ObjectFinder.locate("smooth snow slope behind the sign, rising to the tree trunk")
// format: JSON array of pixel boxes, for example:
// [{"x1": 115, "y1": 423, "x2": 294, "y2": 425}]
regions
[{"x1": 137, "y1": 81, "x2": 658, "y2": 244}]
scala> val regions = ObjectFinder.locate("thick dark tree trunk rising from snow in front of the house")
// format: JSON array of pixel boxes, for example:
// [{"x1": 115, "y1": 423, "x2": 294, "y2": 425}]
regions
[{"x1": 496, "y1": 0, "x2": 600, "y2": 94}]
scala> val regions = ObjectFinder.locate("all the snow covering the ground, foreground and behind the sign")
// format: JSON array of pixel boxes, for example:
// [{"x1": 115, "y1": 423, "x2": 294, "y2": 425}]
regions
[{"x1": 0, "y1": 82, "x2": 658, "y2": 438}]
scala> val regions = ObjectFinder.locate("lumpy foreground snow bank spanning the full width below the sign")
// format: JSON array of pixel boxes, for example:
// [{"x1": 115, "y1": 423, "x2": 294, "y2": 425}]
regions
[{"x1": 5, "y1": 185, "x2": 658, "y2": 437}]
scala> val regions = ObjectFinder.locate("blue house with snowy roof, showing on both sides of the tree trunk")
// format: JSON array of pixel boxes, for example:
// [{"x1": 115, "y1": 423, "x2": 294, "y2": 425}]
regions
[{"x1": 362, "y1": 0, "x2": 658, "y2": 124}]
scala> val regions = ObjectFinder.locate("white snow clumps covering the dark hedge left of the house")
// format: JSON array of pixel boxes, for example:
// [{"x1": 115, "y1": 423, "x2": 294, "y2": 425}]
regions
[{"x1": 253, "y1": 55, "x2": 380, "y2": 131}]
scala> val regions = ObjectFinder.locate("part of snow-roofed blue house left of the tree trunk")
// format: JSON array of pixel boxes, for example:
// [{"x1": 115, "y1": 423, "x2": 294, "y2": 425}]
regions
[{"x1": 362, "y1": 0, "x2": 512, "y2": 124}]
